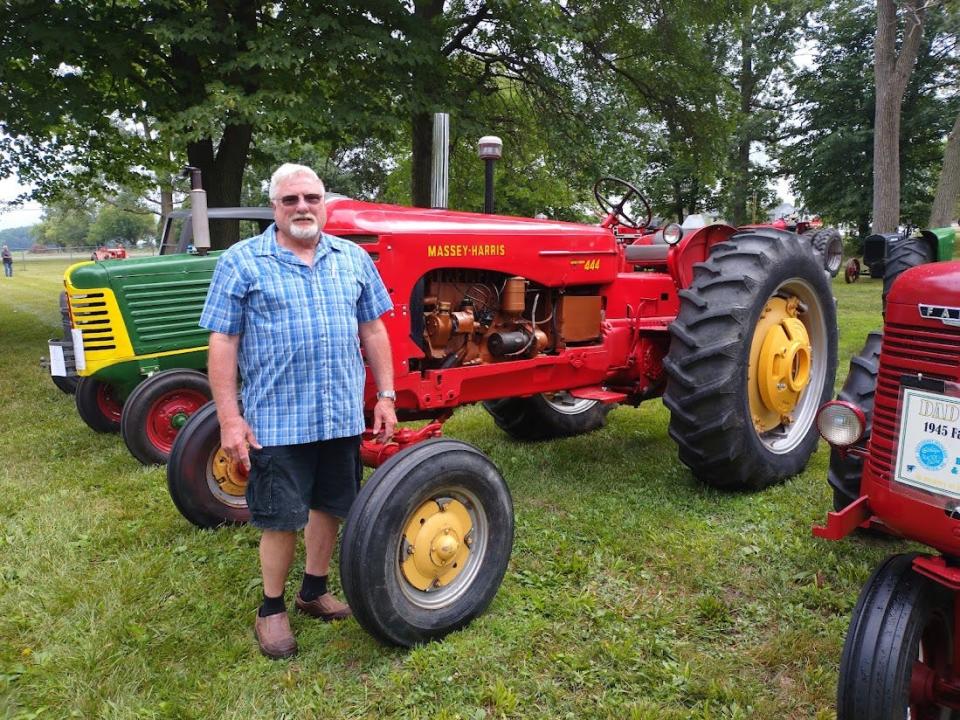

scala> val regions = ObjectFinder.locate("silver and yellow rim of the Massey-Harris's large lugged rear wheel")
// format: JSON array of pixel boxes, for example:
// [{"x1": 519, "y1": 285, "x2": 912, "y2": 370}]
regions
[{"x1": 747, "y1": 278, "x2": 828, "y2": 454}]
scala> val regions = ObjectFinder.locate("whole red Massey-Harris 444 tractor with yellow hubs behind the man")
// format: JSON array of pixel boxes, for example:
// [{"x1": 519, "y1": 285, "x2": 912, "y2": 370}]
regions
[{"x1": 167, "y1": 178, "x2": 837, "y2": 645}]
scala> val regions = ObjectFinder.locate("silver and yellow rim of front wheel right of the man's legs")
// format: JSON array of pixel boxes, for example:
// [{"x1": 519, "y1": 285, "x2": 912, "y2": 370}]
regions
[{"x1": 397, "y1": 487, "x2": 489, "y2": 610}]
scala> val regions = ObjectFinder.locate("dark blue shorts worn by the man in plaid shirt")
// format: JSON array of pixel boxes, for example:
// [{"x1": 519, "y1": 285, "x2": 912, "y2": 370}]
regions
[{"x1": 247, "y1": 435, "x2": 363, "y2": 530}]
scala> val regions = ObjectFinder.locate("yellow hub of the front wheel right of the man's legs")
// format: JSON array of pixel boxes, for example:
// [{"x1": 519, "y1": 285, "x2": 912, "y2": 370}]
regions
[{"x1": 400, "y1": 498, "x2": 473, "y2": 591}]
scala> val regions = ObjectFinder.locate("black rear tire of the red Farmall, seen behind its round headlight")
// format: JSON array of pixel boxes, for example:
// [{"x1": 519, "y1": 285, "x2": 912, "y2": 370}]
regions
[{"x1": 827, "y1": 331, "x2": 883, "y2": 510}]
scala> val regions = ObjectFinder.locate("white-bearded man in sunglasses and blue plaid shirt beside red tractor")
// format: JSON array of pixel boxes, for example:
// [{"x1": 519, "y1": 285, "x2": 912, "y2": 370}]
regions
[{"x1": 200, "y1": 164, "x2": 396, "y2": 658}]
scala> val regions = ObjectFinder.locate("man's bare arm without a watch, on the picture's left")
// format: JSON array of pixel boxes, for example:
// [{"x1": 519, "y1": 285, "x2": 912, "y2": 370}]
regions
[{"x1": 207, "y1": 332, "x2": 260, "y2": 470}]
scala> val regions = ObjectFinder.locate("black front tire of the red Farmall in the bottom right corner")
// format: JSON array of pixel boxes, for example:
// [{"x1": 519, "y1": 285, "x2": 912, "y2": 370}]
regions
[{"x1": 837, "y1": 553, "x2": 960, "y2": 720}]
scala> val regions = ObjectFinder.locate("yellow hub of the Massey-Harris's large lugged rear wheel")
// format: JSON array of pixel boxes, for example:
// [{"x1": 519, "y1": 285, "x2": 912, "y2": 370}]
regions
[{"x1": 747, "y1": 297, "x2": 812, "y2": 432}]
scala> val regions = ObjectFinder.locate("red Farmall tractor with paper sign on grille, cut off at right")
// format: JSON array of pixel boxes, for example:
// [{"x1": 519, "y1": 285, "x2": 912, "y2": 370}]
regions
[{"x1": 814, "y1": 256, "x2": 960, "y2": 720}]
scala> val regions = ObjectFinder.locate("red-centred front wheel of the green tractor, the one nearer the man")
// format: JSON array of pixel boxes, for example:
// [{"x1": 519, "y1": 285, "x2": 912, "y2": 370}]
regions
[{"x1": 120, "y1": 370, "x2": 212, "y2": 465}]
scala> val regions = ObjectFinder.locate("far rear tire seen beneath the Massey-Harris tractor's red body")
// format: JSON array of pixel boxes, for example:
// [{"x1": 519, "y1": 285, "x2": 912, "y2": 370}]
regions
[{"x1": 483, "y1": 393, "x2": 615, "y2": 441}]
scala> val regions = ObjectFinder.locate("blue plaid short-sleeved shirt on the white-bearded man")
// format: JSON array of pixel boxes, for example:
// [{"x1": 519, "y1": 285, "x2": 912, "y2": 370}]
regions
[{"x1": 200, "y1": 225, "x2": 392, "y2": 446}]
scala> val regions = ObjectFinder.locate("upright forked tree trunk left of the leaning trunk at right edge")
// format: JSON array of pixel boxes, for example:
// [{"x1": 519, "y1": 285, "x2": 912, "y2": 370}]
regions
[{"x1": 873, "y1": 0, "x2": 925, "y2": 233}]
